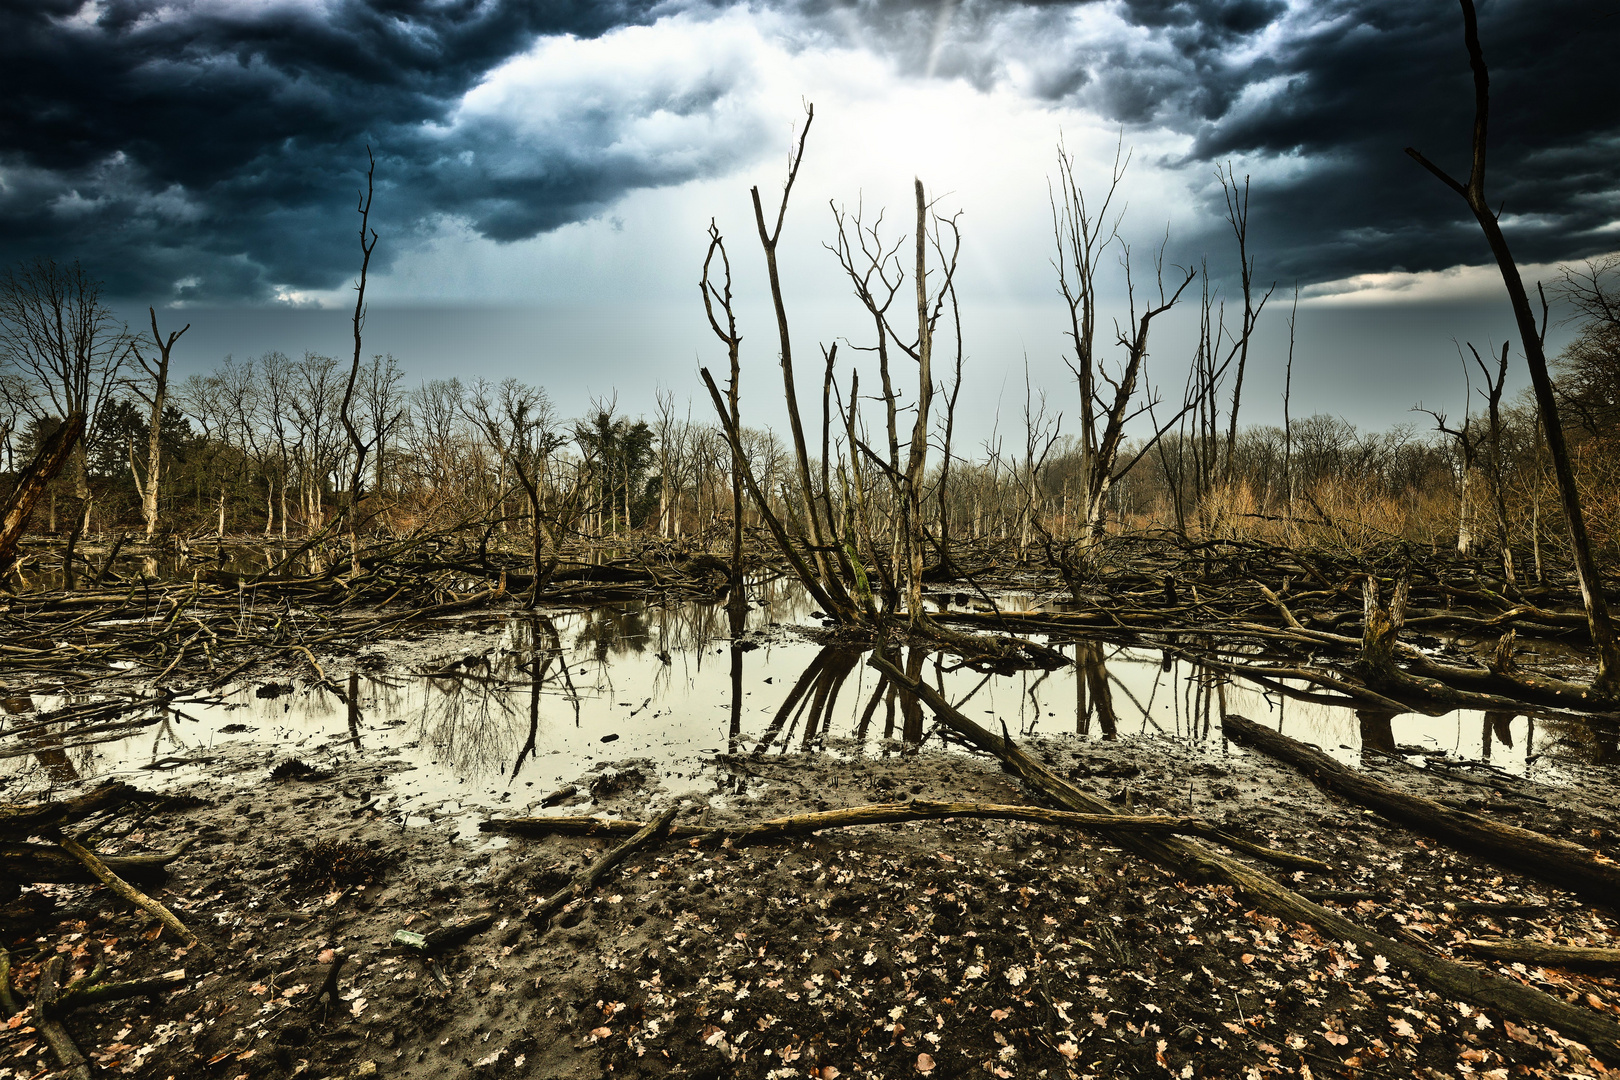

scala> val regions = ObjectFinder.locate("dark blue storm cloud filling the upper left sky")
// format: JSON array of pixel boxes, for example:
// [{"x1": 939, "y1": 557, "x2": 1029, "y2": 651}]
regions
[{"x1": 0, "y1": 0, "x2": 731, "y2": 296}]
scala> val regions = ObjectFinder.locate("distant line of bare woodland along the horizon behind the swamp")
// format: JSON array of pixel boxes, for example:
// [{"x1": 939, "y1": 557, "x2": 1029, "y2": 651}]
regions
[{"x1": 0, "y1": 259, "x2": 1620, "y2": 573}]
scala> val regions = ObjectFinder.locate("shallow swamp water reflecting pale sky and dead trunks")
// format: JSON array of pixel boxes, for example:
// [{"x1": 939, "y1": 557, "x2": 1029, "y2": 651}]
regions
[{"x1": 0, "y1": 583, "x2": 1586, "y2": 834}]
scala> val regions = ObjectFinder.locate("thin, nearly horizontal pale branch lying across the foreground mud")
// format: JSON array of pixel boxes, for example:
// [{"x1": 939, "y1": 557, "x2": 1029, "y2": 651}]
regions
[{"x1": 478, "y1": 800, "x2": 1328, "y2": 873}]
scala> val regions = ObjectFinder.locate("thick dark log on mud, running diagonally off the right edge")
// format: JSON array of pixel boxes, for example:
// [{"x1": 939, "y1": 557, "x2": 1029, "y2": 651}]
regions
[{"x1": 1221, "y1": 714, "x2": 1620, "y2": 907}]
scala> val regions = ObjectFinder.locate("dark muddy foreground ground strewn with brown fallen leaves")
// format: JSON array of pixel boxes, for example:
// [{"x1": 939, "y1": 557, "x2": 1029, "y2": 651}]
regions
[{"x1": 9, "y1": 738, "x2": 1620, "y2": 1080}]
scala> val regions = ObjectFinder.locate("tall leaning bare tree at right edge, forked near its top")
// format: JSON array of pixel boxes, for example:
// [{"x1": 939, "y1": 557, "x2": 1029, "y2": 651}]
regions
[{"x1": 1406, "y1": 0, "x2": 1620, "y2": 698}]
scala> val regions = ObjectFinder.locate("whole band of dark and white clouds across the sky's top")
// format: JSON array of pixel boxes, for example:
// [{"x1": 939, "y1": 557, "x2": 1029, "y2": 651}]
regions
[{"x1": 0, "y1": 0, "x2": 1620, "y2": 300}]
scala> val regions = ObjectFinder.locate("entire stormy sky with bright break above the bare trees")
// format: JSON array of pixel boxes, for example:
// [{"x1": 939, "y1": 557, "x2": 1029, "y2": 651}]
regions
[{"x1": 0, "y1": 0, "x2": 1620, "y2": 440}]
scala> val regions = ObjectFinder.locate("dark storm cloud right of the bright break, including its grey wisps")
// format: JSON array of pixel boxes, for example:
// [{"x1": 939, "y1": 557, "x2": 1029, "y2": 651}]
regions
[{"x1": 805, "y1": 0, "x2": 1620, "y2": 282}]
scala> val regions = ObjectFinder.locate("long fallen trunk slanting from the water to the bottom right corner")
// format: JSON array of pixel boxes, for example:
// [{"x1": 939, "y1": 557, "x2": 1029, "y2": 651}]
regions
[{"x1": 870, "y1": 653, "x2": 1620, "y2": 1061}]
